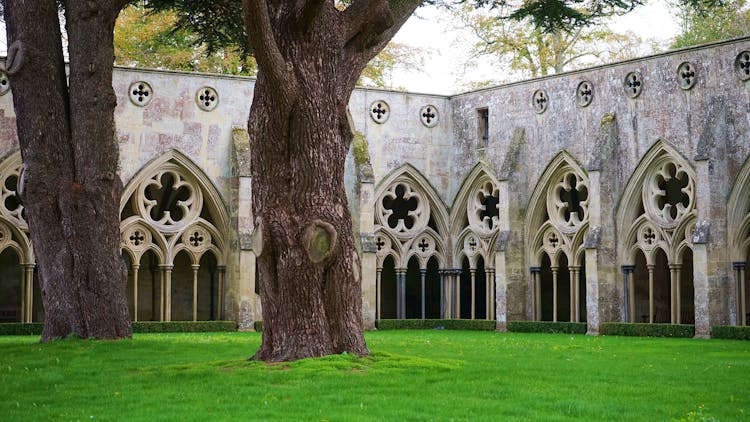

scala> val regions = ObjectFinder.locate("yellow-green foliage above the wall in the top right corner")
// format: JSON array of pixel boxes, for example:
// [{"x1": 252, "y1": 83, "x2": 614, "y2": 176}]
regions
[{"x1": 671, "y1": 0, "x2": 750, "y2": 48}]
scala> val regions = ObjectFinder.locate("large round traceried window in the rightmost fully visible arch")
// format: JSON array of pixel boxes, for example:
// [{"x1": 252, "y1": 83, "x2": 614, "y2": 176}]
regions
[{"x1": 644, "y1": 161, "x2": 694, "y2": 227}]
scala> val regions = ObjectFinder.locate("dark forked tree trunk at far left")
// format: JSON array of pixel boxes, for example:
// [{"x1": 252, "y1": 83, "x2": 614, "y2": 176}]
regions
[{"x1": 5, "y1": 0, "x2": 131, "y2": 341}]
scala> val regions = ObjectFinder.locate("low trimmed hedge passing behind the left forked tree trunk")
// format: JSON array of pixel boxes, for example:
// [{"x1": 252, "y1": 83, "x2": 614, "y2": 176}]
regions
[{"x1": 0, "y1": 321, "x2": 237, "y2": 336}]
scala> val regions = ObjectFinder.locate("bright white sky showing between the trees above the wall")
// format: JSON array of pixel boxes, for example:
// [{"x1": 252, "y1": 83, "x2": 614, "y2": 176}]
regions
[{"x1": 0, "y1": 0, "x2": 679, "y2": 95}]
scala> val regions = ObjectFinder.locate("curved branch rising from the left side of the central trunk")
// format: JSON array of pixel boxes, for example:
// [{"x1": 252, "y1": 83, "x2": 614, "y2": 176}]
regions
[{"x1": 242, "y1": 0, "x2": 299, "y2": 102}]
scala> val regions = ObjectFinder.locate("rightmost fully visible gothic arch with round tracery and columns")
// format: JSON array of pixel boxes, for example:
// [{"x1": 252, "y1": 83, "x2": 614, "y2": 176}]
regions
[{"x1": 616, "y1": 140, "x2": 696, "y2": 324}]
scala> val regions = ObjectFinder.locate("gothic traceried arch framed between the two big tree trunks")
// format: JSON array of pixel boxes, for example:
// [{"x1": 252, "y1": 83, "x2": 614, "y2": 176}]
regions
[{"x1": 120, "y1": 149, "x2": 229, "y2": 321}]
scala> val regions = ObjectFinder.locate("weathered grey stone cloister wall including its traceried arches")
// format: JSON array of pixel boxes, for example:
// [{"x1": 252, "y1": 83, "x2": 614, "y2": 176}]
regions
[{"x1": 0, "y1": 38, "x2": 750, "y2": 336}]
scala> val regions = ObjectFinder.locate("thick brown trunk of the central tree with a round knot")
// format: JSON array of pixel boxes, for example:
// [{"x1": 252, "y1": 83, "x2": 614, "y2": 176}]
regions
[{"x1": 243, "y1": 0, "x2": 420, "y2": 361}]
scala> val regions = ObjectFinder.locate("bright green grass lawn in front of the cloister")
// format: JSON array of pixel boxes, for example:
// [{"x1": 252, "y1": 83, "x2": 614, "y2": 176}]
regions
[{"x1": 0, "y1": 330, "x2": 750, "y2": 421}]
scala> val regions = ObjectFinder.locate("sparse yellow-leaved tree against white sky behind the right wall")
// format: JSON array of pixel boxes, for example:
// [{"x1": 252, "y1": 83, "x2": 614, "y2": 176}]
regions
[{"x1": 452, "y1": 4, "x2": 642, "y2": 82}]
